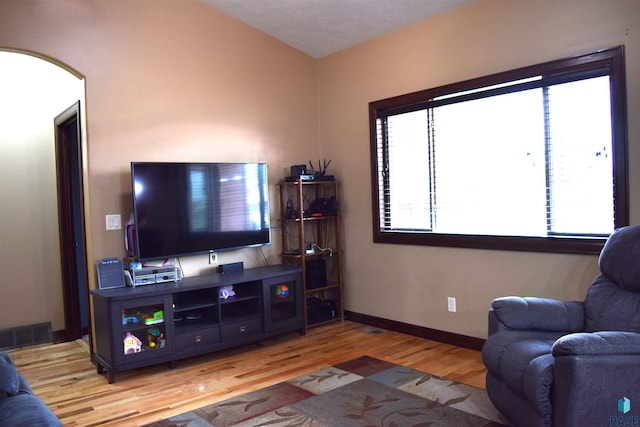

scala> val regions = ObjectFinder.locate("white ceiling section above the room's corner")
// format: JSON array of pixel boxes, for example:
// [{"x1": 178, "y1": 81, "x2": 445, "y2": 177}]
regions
[{"x1": 202, "y1": 0, "x2": 476, "y2": 58}]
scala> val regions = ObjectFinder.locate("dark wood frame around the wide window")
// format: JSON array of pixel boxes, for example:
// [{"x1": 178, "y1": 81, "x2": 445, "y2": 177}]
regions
[{"x1": 369, "y1": 46, "x2": 629, "y2": 254}]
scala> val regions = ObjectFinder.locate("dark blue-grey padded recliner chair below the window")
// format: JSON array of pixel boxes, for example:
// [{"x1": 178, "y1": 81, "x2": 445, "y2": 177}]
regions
[{"x1": 482, "y1": 226, "x2": 640, "y2": 427}]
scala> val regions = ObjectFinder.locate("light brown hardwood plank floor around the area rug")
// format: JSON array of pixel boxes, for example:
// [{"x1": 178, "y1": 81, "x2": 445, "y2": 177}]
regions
[{"x1": 9, "y1": 321, "x2": 486, "y2": 426}]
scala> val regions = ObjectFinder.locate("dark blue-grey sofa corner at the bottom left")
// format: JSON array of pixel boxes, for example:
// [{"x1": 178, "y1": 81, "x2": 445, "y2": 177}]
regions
[{"x1": 0, "y1": 352, "x2": 62, "y2": 427}]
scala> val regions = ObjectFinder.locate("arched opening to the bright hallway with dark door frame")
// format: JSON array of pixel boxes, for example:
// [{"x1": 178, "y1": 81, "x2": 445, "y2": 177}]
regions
[{"x1": 0, "y1": 50, "x2": 90, "y2": 340}]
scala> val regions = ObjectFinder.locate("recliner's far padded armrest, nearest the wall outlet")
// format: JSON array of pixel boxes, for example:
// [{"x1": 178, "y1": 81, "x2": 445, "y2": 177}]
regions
[{"x1": 489, "y1": 297, "x2": 585, "y2": 333}]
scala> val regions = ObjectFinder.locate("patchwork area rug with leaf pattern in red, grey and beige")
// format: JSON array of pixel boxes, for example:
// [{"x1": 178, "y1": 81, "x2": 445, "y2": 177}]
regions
[{"x1": 148, "y1": 356, "x2": 506, "y2": 427}]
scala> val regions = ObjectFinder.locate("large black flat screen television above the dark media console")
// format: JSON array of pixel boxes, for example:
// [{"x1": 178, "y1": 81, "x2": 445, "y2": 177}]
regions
[{"x1": 128, "y1": 162, "x2": 271, "y2": 261}]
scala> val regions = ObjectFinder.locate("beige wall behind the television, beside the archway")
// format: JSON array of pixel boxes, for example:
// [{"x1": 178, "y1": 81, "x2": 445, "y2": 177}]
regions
[{"x1": 0, "y1": 0, "x2": 320, "y2": 329}]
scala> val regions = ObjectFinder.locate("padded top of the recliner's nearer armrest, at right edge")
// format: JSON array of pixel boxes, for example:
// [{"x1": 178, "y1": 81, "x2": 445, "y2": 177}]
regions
[{"x1": 551, "y1": 331, "x2": 640, "y2": 356}]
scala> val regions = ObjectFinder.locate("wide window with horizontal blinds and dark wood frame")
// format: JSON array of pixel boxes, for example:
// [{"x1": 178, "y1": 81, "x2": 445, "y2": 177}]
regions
[{"x1": 369, "y1": 47, "x2": 629, "y2": 254}]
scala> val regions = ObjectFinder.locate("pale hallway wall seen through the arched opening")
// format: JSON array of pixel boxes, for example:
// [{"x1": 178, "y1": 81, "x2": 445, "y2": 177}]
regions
[{"x1": 0, "y1": 51, "x2": 84, "y2": 330}]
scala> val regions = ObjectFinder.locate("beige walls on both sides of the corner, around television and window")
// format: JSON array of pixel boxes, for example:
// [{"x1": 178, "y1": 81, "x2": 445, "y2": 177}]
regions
[{"x1": 0, "y1": 0, "x2": 640, "y2": 337}]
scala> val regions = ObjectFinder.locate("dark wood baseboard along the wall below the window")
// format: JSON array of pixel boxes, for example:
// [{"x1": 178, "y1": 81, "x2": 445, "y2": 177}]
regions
[{"x1": 344, "y1": 310, "x2": 485, "y2": 351}]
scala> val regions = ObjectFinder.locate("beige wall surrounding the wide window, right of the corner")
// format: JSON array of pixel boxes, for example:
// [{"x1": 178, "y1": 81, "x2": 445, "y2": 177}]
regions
[{"x1": 319, "y1": 0, "x2": 640, "y2": 338}]
